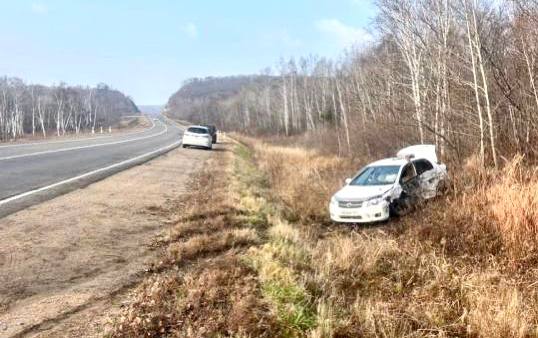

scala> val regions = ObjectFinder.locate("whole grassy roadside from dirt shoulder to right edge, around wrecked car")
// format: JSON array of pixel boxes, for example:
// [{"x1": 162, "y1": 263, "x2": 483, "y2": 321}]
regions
[{"x1": 104, "y1": 139, "x2": 538, "y2": 338}]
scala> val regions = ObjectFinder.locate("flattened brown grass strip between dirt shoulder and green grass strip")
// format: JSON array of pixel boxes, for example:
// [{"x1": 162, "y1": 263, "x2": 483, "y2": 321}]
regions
[{"x1": 108, "y1": 147, "x2": 280, "y2": 337}]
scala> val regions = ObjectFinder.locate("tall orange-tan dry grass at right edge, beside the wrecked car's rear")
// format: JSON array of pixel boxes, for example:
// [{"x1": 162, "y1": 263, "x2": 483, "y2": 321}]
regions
[{"x1": 411, "y1": 156, "x2": 538, "y2": 260}]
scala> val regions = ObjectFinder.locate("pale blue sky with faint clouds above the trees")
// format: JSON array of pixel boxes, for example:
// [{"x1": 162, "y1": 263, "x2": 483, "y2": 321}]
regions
[{"x1": 0, "y1": 0, "x2": 375, "y2": 104}]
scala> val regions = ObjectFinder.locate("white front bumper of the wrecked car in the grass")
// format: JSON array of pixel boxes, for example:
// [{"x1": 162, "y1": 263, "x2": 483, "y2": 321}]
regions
[{"x1": 329, "y1": 201, "x2": 390, "y2": 223}]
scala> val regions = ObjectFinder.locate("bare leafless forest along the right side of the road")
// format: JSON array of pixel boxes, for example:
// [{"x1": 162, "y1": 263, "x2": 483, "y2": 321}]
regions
[{"x1": 168, "y1": 0, "x2": 538, "y2": 166}]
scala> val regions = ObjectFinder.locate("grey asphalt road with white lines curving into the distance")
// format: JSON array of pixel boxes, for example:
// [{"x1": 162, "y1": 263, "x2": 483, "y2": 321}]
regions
[{"x1": 0, "y1": 119, "x2": 183, "y2": 217}]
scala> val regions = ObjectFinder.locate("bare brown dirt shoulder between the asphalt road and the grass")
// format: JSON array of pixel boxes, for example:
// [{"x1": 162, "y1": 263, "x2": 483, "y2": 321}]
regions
[{"x1": 0, "y1": 149, "x2": 211, "y2": 337}]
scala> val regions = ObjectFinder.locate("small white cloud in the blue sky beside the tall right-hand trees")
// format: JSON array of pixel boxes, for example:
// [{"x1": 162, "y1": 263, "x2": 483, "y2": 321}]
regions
[{"x1": 316, "y1": 19, "x2": 373, "y2": 48}]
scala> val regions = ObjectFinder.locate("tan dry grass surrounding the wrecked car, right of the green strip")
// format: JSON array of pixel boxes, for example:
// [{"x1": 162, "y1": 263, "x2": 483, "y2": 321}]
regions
[{"x1": 234, "y1": 138, "x2": 538, "y2": 338}]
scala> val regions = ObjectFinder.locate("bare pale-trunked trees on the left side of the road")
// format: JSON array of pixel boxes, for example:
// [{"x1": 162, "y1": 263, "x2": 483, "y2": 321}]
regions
[{"x1": 0, "y1": 77, "x2": 139, "y2": 140}]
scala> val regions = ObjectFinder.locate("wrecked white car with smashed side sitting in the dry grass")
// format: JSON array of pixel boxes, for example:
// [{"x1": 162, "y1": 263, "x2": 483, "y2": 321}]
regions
[{"x1": 329, "y1": 145, "x2": 448, "y2": 223}]
